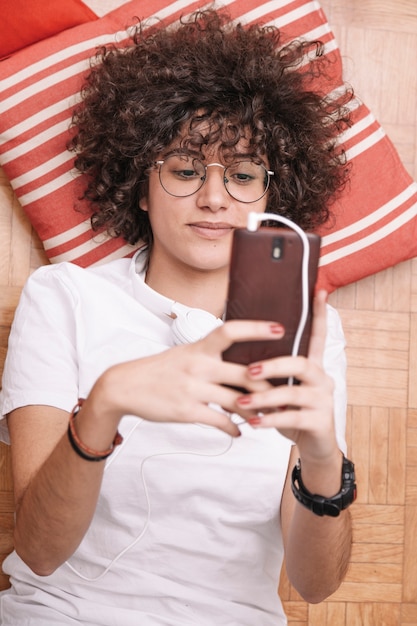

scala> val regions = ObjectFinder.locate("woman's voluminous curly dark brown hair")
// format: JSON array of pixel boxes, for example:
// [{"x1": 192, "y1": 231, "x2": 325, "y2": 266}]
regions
[{"x1": 69, "y1": 9, "x2": 352, "y2": 244}]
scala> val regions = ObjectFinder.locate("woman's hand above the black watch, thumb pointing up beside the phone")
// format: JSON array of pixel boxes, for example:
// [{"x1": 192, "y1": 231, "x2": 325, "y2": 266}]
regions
[{"x1": 237, "y1": 292, "x2": 337, "y2": 462}]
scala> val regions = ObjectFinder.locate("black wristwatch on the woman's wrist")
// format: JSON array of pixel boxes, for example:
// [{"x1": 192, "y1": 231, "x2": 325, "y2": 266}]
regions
[{"x1": 291, "y1": 457, "x2": 356, "y2": 517}]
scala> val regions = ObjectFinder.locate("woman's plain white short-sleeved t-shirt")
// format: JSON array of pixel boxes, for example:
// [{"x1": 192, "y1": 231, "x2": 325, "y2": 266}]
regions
[{"x1": 0, "y1": 251, "x2": 346, "y2": 626}]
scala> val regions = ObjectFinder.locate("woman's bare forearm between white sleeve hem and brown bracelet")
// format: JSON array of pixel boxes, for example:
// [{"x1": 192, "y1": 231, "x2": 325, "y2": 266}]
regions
[{"x1": 8, "y1": 406, "x2": 118, "y2": 576}]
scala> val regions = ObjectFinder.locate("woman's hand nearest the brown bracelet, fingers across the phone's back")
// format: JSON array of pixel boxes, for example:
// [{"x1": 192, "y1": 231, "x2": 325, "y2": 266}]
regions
[{"x1": 87, "y1": 321, "x2": 284, "y2": 436}]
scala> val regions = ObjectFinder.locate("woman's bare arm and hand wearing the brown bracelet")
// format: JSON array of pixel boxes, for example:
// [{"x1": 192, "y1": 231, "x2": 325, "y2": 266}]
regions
[{"x1": 8, "y1": 322, "x2": 280, "y2": 575}]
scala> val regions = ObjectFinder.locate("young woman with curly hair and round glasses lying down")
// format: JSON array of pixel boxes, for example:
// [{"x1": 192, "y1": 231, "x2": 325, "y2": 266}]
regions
[{"x1": 0, "y1": 10, "x2": 354, "y2": 626}]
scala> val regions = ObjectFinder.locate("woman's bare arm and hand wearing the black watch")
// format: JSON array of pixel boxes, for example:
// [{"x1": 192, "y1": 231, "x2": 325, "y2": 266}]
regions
[{"x1": 238, "y1": 293, "x2": 351, "y2": 603}]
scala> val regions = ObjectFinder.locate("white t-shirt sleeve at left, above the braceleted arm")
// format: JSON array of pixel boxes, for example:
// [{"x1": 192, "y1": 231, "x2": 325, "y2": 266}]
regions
[{"x1": 0, "y1": 265, "x2": 78, "y2": 442}]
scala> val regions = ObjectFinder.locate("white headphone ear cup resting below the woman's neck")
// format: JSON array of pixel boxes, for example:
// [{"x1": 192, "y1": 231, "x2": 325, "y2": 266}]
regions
[{"x1": 171, "y1": 302, "x2": 222, "y2": 345}]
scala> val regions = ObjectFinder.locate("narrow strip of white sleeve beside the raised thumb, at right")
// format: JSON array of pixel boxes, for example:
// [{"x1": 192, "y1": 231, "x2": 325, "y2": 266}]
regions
[{"x1": 323, "y1": 305, "x2": 347, "y2": 454}]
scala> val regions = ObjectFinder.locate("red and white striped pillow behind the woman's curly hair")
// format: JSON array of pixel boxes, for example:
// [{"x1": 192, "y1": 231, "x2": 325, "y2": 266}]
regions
[{"x1": 0, "y1": 0, "x2": 417, "y2": 292}]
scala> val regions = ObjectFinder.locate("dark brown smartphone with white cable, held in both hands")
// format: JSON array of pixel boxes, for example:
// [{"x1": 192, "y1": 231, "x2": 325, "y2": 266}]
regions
[{"x1": 223, "y1": 227, "x2": 320, "y2": 385}]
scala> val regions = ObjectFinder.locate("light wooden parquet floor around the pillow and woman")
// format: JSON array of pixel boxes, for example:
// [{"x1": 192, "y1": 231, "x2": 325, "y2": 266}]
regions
[{"x1": 0, "y1": 0, "x2": 417, "y2": 626}]
